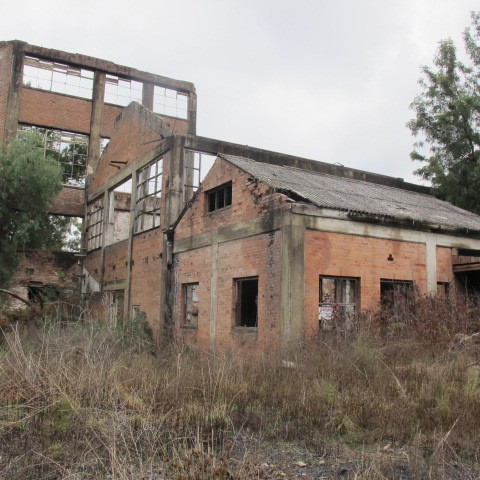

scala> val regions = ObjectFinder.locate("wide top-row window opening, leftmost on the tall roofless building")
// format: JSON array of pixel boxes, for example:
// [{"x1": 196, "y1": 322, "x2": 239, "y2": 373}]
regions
[{"x1": 23, "y1": 57, "x2": 93, "y2": 99}]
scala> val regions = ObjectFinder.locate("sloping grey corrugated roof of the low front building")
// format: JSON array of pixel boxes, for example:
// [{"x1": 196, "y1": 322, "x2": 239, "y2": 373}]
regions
[{"x1": 219, "y1": 154, "x2": 480, "y2": 231}]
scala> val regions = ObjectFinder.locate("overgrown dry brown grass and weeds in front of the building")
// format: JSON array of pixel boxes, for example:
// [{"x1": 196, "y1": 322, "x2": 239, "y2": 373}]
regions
[{"x1": 0, "y1": 299, "x2": 480, "y2": 479}]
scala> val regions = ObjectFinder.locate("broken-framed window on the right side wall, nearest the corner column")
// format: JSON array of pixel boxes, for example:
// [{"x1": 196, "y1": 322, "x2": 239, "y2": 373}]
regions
[{"x1": 318, "y1": 276, "x2": 360, "y2": 330}]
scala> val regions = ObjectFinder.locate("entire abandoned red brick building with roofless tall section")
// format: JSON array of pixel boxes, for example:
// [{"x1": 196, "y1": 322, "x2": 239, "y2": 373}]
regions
[{"x1": 0, "y1": 42, "x2": 480, "y2": 351}]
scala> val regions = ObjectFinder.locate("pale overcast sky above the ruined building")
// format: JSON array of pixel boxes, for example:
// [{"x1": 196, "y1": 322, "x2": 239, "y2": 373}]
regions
[{"x1": 0, "y1": 0, "x2": 480, "y2": 181}]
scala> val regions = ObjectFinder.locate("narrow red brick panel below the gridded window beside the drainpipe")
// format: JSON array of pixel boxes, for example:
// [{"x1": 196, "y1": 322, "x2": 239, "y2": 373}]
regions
[{"x1": 129, "y1": 228, "x2": 163, "y2": 339}]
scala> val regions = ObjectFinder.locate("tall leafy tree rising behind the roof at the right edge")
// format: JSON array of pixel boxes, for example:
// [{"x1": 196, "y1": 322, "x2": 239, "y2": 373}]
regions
[{"x1": 407, "y1": 12, "x2": 480, "y2": 213}]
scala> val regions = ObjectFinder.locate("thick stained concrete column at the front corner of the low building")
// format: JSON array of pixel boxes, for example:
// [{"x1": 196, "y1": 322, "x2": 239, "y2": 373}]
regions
[{"x1": 280, "y1": 212, "x2": 305, "y2": 359}]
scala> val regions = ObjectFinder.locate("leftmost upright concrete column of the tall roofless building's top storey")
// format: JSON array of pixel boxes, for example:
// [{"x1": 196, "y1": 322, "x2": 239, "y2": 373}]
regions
[{"x1": 3, "y1": 42, "x2": 25, "y2": 142}]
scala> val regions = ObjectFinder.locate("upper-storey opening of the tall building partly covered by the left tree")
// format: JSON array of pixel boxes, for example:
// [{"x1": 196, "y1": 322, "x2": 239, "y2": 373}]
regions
[{"x1": 18, "y1": 125, "x2": 88, "y2": 186}]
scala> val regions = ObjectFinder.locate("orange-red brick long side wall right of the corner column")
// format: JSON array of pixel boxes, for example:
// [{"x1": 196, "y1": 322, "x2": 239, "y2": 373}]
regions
[{"x1": 305, "y1": 230, "x2": 426, "y2": 338}]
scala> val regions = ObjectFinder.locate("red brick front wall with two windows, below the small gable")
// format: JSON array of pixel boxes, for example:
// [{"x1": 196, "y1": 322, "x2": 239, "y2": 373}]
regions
[{"x1": 174, "y1": 232, "x2": 281, "y2": 349}]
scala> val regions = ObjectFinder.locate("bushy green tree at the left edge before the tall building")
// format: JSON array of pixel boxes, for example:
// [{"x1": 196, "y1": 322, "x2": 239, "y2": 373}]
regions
[{"x1": 0, "y1": 132, "x2": 62, "y2": 287}]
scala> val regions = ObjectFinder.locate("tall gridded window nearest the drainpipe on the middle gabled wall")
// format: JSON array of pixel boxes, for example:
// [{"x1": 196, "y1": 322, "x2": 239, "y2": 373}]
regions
[{"x1": 135, "y1": 158, "x2": 163, "y2": 233}]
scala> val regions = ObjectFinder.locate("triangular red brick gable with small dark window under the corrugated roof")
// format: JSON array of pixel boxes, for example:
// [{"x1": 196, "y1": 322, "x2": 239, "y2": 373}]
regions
[{"x1": 175, "y1": 158, "x2": 288, "y2": 239}]
